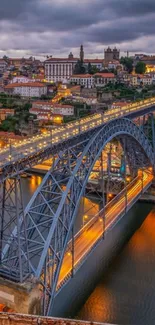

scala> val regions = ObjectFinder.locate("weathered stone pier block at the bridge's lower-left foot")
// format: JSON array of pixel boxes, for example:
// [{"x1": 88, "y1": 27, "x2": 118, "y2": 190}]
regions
[{"x1": 0, "y1": 278, "x2": 42, "y2": 315}]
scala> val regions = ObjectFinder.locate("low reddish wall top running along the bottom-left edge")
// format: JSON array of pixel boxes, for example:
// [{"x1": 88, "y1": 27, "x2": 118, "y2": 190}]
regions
[{"x1": 0, "y1": 313, "x2": 112, "y2": 325}]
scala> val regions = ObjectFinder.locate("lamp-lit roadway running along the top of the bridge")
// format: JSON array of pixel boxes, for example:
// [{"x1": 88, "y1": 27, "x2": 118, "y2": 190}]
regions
[{"x1": 0, "y1": 97, "x2": 155, "y2": 168}]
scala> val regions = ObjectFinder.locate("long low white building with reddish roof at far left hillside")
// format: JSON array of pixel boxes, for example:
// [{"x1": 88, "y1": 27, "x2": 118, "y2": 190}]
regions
[{"x1": 4, "y1": 82, "x2": 47, "y2": 97}]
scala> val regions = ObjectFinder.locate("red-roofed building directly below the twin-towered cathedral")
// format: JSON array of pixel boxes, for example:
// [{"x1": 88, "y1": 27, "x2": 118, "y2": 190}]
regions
[{"x1": 93, "y1": 72, "x2": 116, "y2": 87}]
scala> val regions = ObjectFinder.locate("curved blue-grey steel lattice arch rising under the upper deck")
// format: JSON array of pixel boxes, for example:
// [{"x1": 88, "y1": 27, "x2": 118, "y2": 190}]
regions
[{"x1": 0, "y1": 118, "x2": 154, "y2": 313}]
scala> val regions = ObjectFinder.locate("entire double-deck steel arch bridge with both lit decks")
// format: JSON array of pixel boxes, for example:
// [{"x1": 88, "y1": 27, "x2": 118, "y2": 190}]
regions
[{"x1": 0, "y1": 98, "x2": 155, "y2": 315}]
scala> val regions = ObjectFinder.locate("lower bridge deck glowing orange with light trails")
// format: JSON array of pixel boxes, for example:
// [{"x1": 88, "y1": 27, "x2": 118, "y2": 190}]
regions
[{"x1": 57, "y1": 172, "x2": 153, "y2": 291}]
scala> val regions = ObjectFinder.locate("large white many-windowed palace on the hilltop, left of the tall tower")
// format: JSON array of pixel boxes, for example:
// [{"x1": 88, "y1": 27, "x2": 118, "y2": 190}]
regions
[{"x1": 45, "y1": 54, "x2": 78, "y2": 82}]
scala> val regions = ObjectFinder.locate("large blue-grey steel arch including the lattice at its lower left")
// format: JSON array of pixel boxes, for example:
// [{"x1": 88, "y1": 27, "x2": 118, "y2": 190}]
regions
[{"x1": 0, "y1": 118, "x2": 154, "y2": 314}]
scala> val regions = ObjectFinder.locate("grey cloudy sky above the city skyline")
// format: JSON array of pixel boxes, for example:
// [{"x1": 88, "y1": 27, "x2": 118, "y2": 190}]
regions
[{"x1": 0, "y1": 0, "x2": 155, "y2": 58}]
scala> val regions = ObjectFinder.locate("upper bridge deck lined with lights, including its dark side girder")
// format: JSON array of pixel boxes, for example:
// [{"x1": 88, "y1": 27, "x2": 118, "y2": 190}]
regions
[{"x1": 0, "y1": 97, "x2": 155, "y2": 179}]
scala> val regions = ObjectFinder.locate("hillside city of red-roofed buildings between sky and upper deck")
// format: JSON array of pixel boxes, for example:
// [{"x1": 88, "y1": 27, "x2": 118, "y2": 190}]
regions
[{"x1": 0, "y1": 45, "x2": 155, "y2": 147}]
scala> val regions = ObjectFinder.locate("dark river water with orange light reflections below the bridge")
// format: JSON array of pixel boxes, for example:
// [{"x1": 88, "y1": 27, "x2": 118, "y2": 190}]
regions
[{"x1": 23, "y1": 176, "x2": 155, "y2": 325}]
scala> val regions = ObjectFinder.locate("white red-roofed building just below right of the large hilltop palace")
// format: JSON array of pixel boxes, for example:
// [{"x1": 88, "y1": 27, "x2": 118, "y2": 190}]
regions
[{"x1": 70, "y1": 74, "x2": 94, "y2": 88}]
